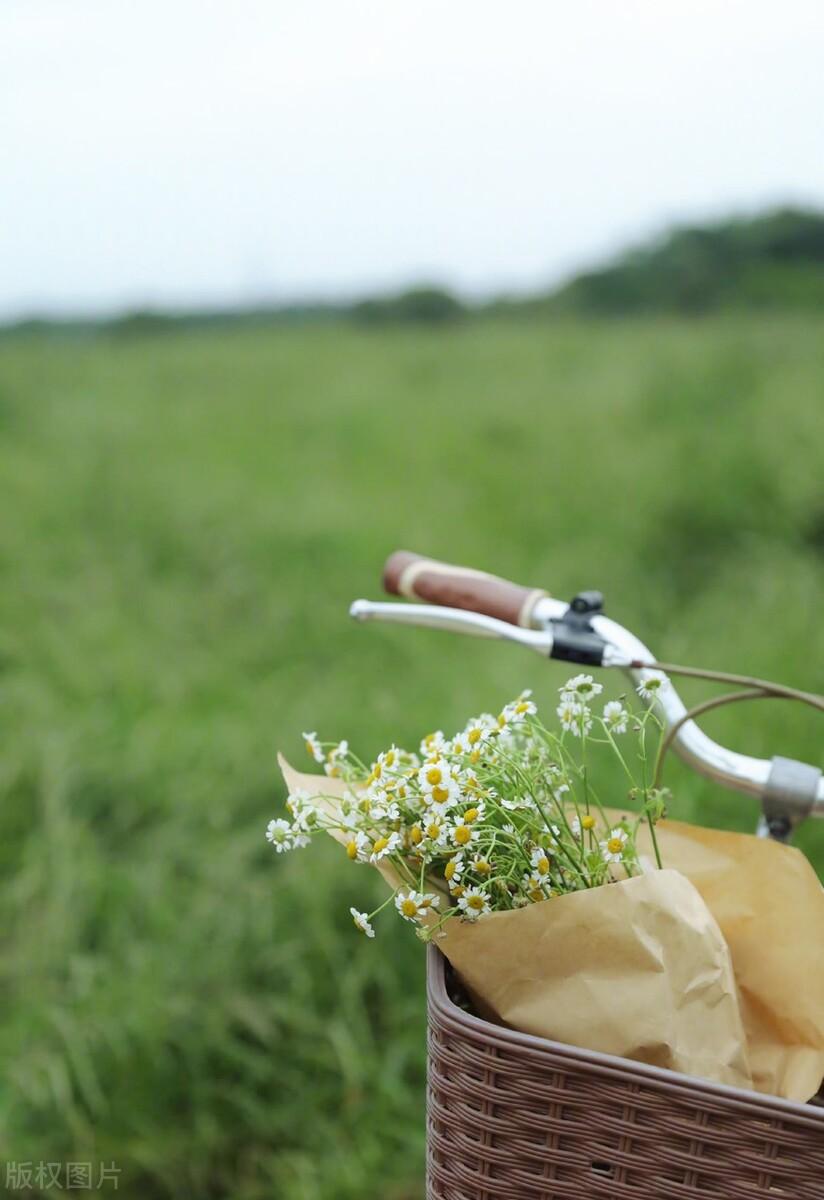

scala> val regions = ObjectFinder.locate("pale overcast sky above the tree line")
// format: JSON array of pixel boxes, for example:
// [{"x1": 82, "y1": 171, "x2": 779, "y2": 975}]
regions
[{"x1": 0, "y1": 0, "x2": 824, "y2": 317}]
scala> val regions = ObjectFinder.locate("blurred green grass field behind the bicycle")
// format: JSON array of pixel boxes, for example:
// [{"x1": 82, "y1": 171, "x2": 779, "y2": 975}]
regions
[{"x1": 0, "y1": 317, "x2": 824, "y2": 1200}]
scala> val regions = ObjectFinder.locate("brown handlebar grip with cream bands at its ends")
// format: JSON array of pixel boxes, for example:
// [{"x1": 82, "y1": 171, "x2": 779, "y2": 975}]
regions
[{"x1": 384, "y1": 550, "x2": 548, "y2": 629}]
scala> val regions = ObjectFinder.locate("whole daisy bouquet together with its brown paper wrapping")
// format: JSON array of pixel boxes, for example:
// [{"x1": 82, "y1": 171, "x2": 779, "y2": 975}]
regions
[{"x1": 273, "y1": 672, "x2": 824, "y2": 1099}]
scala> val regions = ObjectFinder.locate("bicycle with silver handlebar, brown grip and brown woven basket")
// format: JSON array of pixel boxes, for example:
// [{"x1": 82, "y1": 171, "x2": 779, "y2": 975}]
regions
[{"x1": 350, "y1": 551, "x2": 824, "y2": 1200}]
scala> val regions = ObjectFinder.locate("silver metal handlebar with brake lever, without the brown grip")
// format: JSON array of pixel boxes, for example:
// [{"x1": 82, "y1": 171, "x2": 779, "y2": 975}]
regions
[{"x1": 349, "y1": 596, "x2": 824, "y2": 841}]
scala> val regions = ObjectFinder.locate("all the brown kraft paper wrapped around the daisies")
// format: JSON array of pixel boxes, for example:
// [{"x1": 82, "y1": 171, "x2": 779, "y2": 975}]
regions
[{"x1": 279, "y1": 758, "x2": 824, "y2": 1100}]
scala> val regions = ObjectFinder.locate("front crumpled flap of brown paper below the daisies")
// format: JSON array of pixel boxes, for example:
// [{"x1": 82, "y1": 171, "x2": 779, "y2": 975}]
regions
[{"x1": 438, "y1": 870, "x2": 752, "y2": 1087}]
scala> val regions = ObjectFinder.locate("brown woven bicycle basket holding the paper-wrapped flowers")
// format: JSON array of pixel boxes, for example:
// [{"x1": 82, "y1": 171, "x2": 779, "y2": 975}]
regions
[{"x1": 427, "y1": 947, "x2": 824, "y2": 1200}]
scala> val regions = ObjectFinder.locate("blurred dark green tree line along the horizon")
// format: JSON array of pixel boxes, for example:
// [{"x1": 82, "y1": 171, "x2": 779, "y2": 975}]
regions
[{"x1": 0, "y1": 208, "x2": 824, "y2": 337}]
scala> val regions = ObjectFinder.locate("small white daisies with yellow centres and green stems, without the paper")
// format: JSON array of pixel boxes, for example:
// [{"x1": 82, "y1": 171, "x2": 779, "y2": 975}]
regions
[{"x1": 266, "y1": 674, "x2": 666, "y2": 940}]
